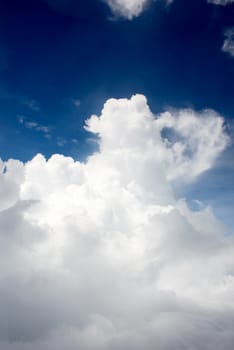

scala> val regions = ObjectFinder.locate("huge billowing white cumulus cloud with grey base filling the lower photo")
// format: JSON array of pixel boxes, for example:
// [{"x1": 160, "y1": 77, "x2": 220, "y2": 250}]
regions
[{"x1": 0, "y1": 95, "x2": 234, "y2": 350}]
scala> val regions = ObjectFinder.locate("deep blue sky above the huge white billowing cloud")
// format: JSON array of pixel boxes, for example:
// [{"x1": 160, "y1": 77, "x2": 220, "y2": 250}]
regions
[{"x1": 0, "y1": 0, "x2": 234, "y2": 160}]
